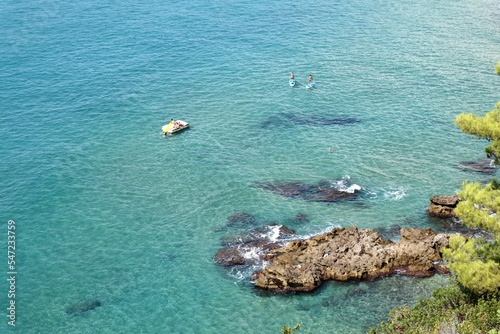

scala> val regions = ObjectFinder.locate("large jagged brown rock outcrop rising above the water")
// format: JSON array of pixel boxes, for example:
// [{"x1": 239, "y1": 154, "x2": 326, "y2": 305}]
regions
[{"x1": 253, "y1": 227, "x2": 449, "y2": 292}]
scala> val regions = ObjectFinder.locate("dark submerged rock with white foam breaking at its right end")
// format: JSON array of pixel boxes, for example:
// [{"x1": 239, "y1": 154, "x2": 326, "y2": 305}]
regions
[{"x1": 254, "y1": 180, "x2": 361, "y2": 202}]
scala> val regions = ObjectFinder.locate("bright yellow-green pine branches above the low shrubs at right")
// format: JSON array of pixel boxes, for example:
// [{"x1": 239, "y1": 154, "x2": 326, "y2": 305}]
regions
[{"x1": 443, "y1": 102, "x2": 500, "y2": 295}]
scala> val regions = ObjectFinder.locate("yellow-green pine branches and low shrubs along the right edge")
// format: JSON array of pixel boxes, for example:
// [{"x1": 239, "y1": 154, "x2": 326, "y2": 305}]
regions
[{"x1": 369, "y1": 61, "x2": 500, "y2": 334}]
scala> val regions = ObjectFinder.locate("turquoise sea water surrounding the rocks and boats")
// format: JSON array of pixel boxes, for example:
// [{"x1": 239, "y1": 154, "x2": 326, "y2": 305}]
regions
[{"x1": 0, "y1": 0, "x2": 500, "y2": 334}]
